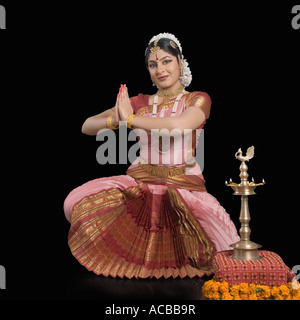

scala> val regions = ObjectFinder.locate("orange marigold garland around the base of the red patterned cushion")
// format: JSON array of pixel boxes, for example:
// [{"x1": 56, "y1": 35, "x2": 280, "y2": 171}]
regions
[{"x1": 202, "y1": 280, "x2": 300, "y2": 300}]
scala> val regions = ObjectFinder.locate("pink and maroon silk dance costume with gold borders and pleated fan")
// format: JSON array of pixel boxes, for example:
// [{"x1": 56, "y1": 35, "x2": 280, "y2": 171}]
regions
[{"x1": 64, "y1": 92, "x2": 239, "y2": 278}]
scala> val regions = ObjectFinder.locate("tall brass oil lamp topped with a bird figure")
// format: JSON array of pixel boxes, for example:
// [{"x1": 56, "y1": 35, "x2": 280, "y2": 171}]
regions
[{"x1": 225, "y1": 146, "x2": 265, "y2": 260}]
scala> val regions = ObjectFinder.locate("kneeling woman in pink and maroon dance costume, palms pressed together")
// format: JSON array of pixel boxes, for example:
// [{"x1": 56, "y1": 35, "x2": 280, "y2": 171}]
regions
[{"x1": 64, "y1": 33, "x2": 239, "y2": 278}]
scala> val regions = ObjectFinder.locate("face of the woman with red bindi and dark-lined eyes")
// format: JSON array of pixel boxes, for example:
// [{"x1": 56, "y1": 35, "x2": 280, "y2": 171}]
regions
[{"x1": 148, "y1": 49, "x2": 183, "y2": 91}]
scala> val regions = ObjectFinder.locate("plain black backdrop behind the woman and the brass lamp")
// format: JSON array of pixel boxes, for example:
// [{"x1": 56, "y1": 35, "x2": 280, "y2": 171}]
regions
[{"x1": 0, "y1": 1, "x2": 300, "y2": 299}]
